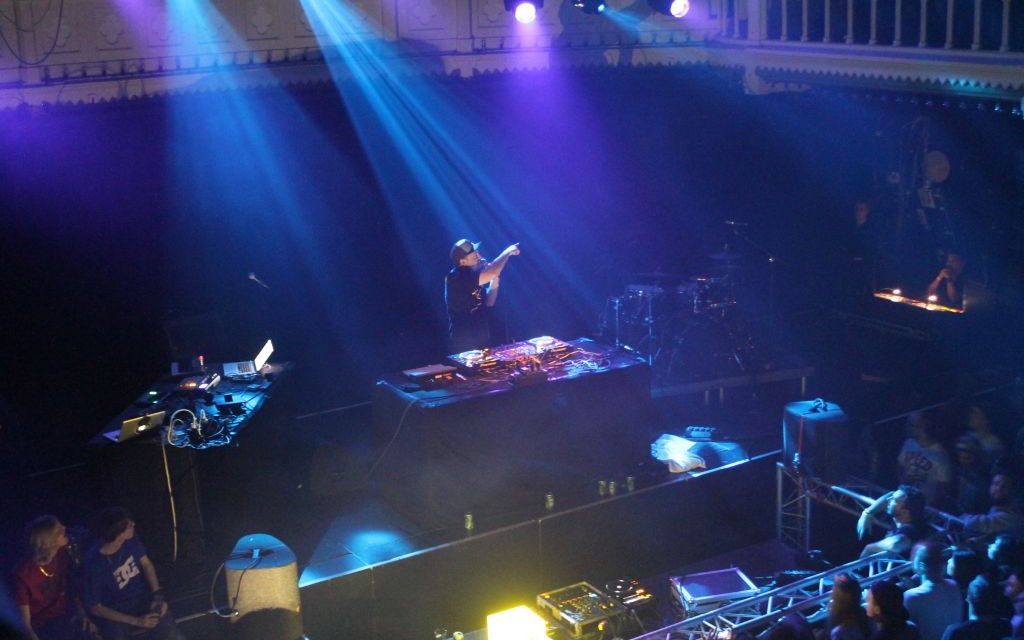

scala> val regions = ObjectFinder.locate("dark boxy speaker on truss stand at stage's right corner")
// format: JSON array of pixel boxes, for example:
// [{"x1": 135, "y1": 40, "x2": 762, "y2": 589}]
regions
[{"x1": 782, "y1": 398, "x2": 854, "y2": 484}]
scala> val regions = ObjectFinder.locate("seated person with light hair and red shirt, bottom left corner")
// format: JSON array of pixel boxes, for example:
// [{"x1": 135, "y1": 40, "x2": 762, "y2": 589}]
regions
[{"x1": 13, "y1": 515, "x2": 96, "y2": 640}]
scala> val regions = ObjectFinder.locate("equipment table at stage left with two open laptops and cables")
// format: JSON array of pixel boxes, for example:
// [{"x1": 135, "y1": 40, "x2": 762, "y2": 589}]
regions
[{"x1": 89, "y1": 364, "x2": 289, "y2": 561}]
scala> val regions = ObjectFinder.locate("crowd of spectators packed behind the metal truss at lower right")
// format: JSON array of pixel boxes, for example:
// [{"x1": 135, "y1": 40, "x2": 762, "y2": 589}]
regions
[{"x1": 749, "y1": 389, "x2": 1024, "y2": 640}]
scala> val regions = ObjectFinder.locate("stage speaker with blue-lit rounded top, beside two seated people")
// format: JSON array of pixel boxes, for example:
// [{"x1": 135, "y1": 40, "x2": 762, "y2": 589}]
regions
[{"x1": 224, "y1": 534, "x2": 303, "y2": 640}]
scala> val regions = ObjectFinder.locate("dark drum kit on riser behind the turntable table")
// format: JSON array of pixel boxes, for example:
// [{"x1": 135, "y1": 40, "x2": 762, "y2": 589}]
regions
[{"x1": 600, "y1": 253, "x2": 754, "y2": 376}]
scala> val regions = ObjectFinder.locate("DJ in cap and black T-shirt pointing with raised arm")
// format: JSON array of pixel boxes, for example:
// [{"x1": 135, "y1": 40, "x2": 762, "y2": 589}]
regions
[{"x1": 444, "y1": 239, "x2": 519, "y2": 353}]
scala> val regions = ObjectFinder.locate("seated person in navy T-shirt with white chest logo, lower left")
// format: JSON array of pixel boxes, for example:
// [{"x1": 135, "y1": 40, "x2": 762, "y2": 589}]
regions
[{"x1": 83, "y1": 507, "x2": 183, "y2": 640}]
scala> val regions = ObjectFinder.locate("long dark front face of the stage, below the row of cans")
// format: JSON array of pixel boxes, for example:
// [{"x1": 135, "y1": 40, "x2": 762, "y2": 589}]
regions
[{"x1": 301, "y1": 454, "x2": 778, "y2": 639}]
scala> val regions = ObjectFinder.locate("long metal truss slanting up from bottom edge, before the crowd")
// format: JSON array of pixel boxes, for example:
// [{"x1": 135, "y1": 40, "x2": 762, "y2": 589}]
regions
[{"x1": 634, "y1": 553, "x2": 913, "y2": 640}]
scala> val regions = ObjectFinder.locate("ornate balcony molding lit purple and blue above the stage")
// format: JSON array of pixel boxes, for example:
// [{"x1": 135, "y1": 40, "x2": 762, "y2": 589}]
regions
[{"x1": 0, "y1": 0, "x2": 1024, "y2": 109}]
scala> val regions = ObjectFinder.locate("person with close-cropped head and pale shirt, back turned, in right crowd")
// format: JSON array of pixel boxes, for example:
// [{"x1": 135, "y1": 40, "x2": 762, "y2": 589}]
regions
[{"x1": 903, "y1": 541, "x2": 964, "y2": 640}]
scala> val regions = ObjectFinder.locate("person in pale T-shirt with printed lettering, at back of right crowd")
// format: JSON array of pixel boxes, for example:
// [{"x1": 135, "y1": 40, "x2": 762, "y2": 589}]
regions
[{"x1": 896, "y1": 412, "x2": 953, "y2": 509}]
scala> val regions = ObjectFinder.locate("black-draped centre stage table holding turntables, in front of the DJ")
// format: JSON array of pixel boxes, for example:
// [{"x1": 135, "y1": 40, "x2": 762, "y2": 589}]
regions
[{"x1": 373, "y1": 339, "x2": 653, "y2": 530}]
